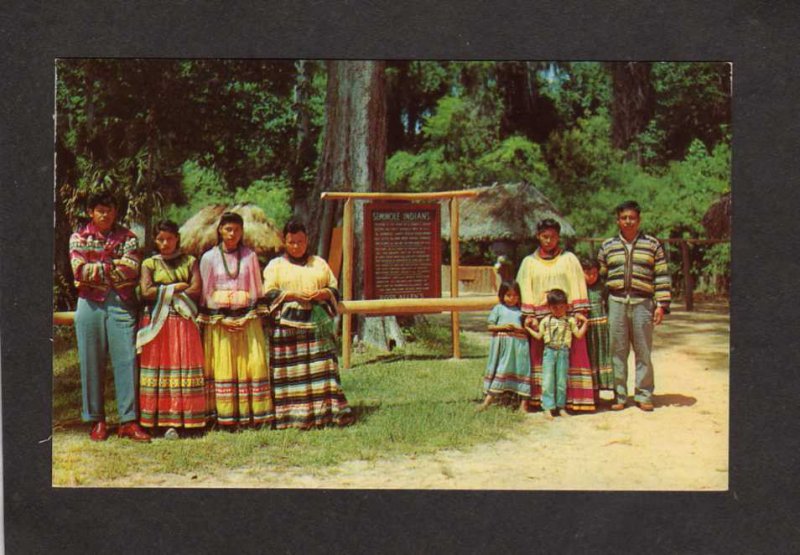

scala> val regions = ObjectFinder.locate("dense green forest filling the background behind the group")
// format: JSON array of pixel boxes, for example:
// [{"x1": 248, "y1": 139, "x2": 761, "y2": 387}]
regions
[{"x1": 53, "y1": 59, "x2": 731, "y2": 310}]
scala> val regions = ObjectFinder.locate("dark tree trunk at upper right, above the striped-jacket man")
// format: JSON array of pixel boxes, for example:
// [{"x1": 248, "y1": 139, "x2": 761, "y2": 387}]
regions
[{"x1": 609, "y1": 62, "x2": 655, "y2": 150}]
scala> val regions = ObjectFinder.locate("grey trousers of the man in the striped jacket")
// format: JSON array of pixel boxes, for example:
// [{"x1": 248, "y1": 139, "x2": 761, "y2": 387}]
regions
[{"x1": 608, "y1": 299, "x2": 655, "y2": 403}]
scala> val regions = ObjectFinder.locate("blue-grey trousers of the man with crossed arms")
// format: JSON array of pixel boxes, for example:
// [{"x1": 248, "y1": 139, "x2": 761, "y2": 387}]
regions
[{"x1": 75, "y1": 291, "x2": 139, "y2": 423}]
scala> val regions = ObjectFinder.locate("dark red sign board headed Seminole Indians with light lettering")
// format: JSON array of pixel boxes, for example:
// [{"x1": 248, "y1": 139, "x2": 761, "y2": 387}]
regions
[{"x1": 364, "y1": 202, "x2": 442, "y2": 299}]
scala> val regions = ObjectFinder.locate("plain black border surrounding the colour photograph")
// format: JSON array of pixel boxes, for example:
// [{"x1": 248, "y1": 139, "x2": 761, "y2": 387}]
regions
[{"x1": 0, "y1": 0, "x2": 800, "y2": 553}]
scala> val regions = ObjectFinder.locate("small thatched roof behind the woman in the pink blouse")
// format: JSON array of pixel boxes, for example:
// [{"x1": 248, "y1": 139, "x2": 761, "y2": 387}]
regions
[{"x1": 180, "y1": 204, "x2": 283, "y2": 258}]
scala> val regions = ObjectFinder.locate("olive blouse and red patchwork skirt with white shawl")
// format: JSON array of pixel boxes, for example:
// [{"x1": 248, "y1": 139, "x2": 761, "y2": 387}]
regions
[{"x1": 136, "y1": 254, "x2": 206, "y2": 428}]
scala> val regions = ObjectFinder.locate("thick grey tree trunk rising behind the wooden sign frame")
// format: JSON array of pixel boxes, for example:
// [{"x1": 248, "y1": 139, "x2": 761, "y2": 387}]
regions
[{"x1": 308, "y1": 61, "x2": 404, "y2": 349}]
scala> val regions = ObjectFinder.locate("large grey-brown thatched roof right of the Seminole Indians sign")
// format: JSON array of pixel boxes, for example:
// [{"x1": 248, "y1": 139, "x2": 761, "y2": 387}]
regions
[{"x1": 442, "y1": 182, "x2": 575, "y2": 242}]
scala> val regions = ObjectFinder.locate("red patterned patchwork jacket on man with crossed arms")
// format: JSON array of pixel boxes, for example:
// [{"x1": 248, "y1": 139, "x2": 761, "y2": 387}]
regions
[{"x1": 69, "y1": 222, "x2": 141, "y2": 302}]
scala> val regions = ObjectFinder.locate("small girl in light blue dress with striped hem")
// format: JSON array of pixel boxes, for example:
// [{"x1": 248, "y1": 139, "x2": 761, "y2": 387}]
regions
[{"x1": 479, "y1": 281, "x2": 531, "y2": 413}]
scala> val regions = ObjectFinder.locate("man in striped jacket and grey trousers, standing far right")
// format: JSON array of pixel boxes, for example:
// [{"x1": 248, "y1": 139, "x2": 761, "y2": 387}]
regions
[{"x1": 597, "y1": 200, "x2": 671, "y2": 412}]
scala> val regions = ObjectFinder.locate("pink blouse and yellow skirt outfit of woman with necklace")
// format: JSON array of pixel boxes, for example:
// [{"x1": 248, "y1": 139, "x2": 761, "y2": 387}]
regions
[{"x1": 198, "y1": 245, "x2": 272, "y2": 426}]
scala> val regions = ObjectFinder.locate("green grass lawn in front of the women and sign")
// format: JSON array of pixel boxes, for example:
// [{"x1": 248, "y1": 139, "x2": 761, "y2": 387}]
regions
[{"x1": 48, "y1": 325, "x2": 525, "y2": 486}]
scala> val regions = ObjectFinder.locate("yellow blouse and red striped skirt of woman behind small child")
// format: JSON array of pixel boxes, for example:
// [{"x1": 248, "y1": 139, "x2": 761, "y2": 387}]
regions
[{"x1": 517, "y1": 249, "x2": 595, "y2": 411}]
